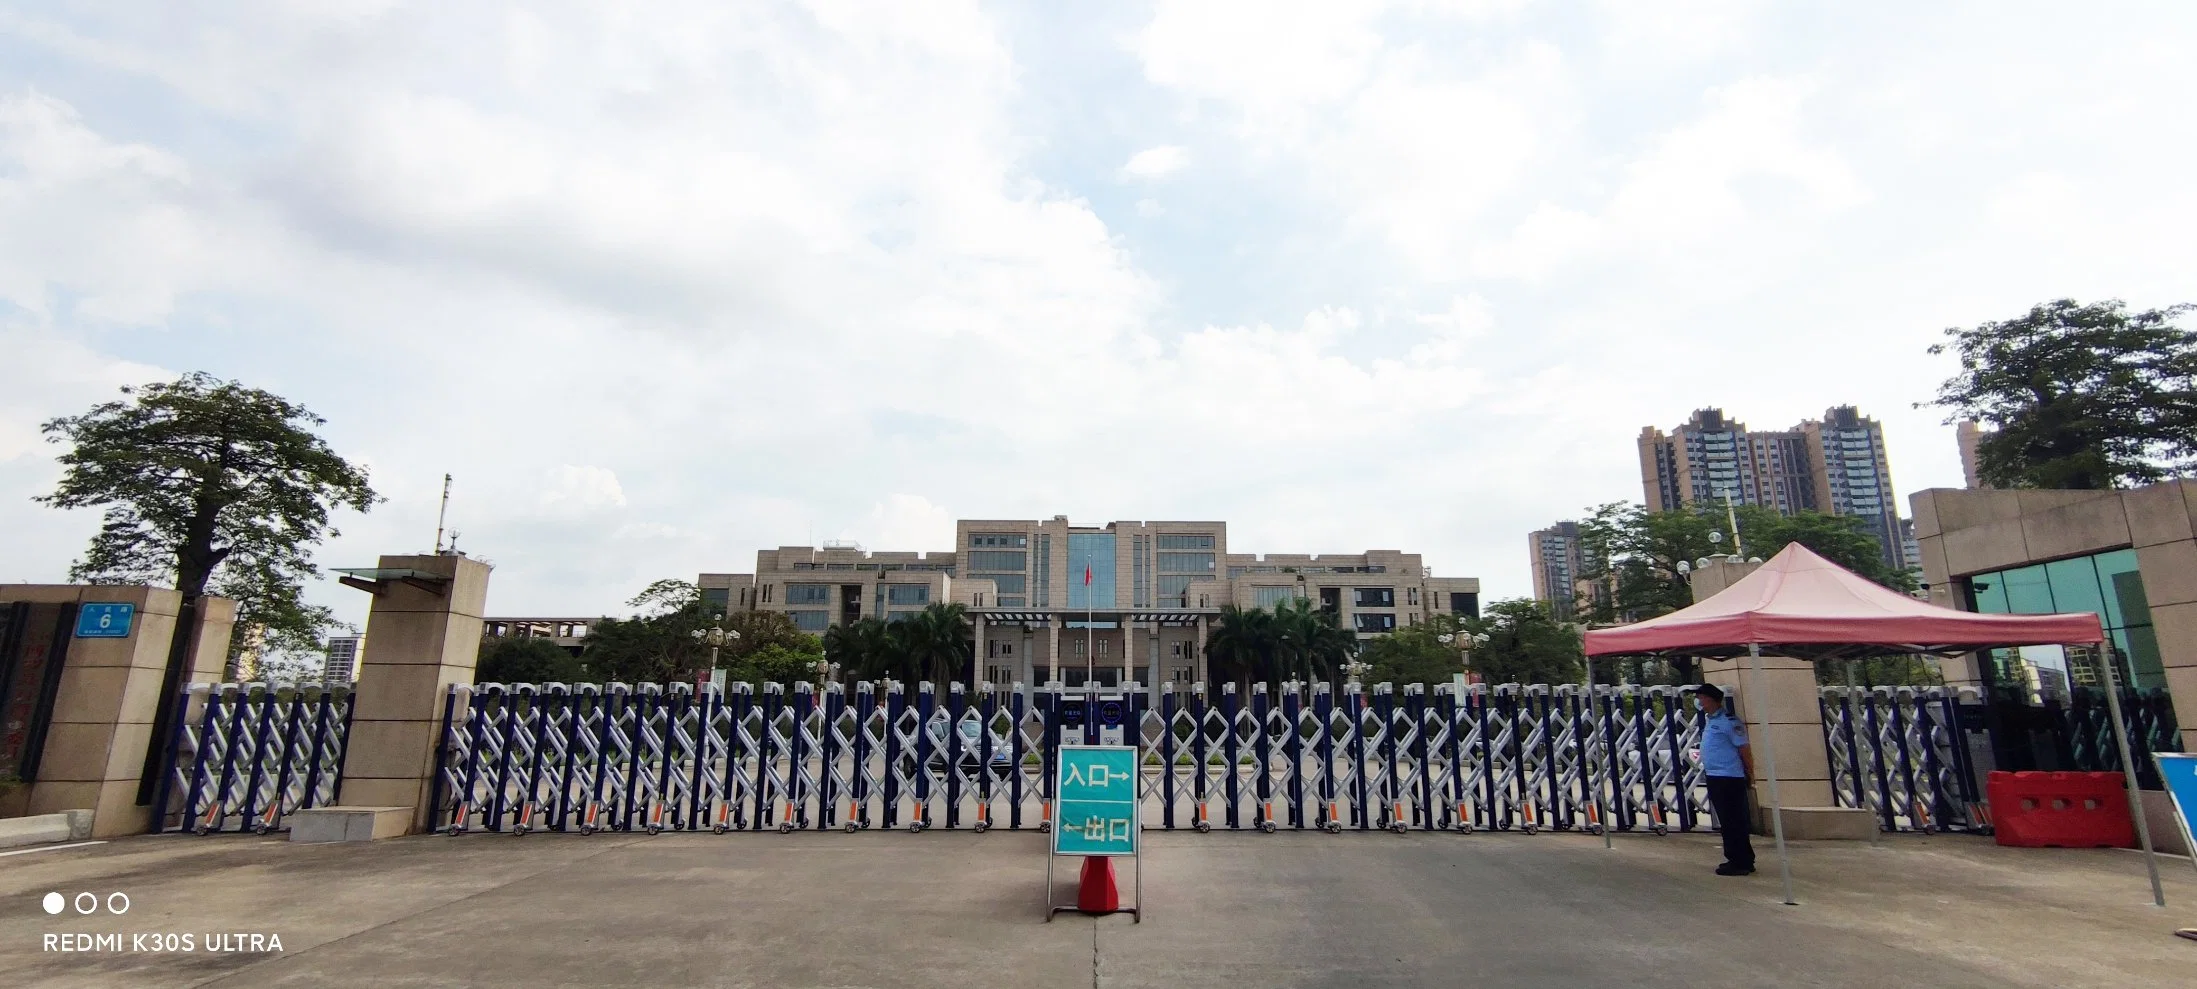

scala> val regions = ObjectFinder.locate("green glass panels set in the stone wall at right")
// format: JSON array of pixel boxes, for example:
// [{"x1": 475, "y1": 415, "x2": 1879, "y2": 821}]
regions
[{"x1": 1966, "y1": 549, "x2": 2166, "y2": 688}]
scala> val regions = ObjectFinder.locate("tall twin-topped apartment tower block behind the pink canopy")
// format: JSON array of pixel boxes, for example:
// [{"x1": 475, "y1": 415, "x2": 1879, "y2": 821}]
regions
[{"x1": 1639, "y1": 404, "x2": 1914, "y2": 567}]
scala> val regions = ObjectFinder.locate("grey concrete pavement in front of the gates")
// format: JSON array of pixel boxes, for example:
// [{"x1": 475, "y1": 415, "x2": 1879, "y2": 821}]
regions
[{"x1": 0, "y1": 833, "x2": 2197, "y2": 989}]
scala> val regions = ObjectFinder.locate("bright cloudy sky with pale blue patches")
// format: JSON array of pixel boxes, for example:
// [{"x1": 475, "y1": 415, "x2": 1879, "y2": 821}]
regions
[{"x1": 0, "y1": 0, "x2": 2197, "y2": 618}]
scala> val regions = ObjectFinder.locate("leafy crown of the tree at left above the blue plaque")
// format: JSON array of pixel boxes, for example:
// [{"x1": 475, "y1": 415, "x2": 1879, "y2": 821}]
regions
[{"x1": 37, "y1": 374, "x2": 378, "y2": 663}]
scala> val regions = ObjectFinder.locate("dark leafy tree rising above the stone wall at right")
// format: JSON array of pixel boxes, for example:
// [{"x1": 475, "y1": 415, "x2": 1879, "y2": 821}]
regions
[{"x1": 1925, "y1": 299, "x2": 2197, "y2": 488}]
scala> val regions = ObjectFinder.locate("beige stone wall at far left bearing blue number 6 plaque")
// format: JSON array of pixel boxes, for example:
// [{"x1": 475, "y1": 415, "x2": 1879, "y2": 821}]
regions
[{"x1": 0, "y1": 585, "x2": 237, "y2": 837}]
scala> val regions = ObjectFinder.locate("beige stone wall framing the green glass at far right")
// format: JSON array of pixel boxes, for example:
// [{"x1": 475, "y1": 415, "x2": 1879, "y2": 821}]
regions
[{"x1": 1911, "y1": 479, "x2": 2197, "y2": 752}]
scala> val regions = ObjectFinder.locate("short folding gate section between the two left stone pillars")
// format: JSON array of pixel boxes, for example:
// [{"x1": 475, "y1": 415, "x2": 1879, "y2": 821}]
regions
[{"x1": 154, "y1": 681, "x2": 352, "y2": 835}]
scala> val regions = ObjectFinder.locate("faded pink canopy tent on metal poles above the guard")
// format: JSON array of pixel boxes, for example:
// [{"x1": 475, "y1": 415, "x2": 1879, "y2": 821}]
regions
[{"x1": 1586, "y1": 543, "x2": 2164, "y2": 905}]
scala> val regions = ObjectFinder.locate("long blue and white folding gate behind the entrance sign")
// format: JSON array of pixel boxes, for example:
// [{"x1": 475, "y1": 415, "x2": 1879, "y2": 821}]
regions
[{"x1": 431, "y1": 681, "x2": 1714, "y2": 833}]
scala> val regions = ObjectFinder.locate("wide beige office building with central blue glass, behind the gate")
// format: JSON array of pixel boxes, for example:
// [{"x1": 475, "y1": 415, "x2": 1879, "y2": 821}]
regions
[{"x1": 696, "y1": 516, "x2": 1481, "y2": 686}]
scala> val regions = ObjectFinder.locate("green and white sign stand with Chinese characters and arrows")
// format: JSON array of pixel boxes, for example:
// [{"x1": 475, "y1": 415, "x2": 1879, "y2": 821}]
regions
[{"x1": 1046, "y1": 745, "x2": 1145, "y2": 923}]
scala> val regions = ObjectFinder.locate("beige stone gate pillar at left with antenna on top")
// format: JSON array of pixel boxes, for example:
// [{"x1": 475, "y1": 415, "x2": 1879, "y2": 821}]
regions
[{"x1": 338, "y1": 554, "x2": 490, "y2": 833}]
